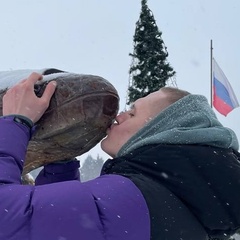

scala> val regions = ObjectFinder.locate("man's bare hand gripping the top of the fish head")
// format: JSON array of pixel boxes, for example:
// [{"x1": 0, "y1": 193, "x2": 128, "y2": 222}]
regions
[{"x1": 3, "y1": 73, "x2": 56, "y2": 123}]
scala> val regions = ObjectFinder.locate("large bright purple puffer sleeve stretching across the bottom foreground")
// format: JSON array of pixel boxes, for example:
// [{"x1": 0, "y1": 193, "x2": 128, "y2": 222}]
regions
[{"x1": 0, "y1": 175, "x2": 150, "y2": 240}]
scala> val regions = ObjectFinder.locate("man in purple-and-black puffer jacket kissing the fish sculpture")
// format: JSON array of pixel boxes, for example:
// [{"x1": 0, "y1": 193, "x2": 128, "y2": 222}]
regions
[{"x1": 0, "y1": 73, "x2": 240, "y2": 240}]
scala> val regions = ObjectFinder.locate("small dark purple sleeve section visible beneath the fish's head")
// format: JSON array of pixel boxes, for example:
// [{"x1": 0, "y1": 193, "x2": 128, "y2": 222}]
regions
[{"x1": 35, "y1": 160, "x2": 80, "y2": 185}]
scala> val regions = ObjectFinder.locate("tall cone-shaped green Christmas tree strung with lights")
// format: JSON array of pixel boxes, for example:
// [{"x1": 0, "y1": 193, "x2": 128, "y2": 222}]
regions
[{"x1": 127, "y1": 0, "x2": 175, "y2": 104}]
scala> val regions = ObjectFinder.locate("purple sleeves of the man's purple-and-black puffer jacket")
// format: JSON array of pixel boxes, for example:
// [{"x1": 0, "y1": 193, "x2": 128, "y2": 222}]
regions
[{"x1": 0, "y1": 117, "x2": 150, "y2": 240}]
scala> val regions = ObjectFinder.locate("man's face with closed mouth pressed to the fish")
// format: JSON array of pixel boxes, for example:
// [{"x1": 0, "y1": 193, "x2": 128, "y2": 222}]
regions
[{"x1": 101, "y1": 90, "x2": 169, "y2": 157}]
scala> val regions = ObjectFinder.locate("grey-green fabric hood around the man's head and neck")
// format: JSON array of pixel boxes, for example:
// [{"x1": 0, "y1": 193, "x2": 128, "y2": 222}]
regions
[{"x1": 117, "y1": 94, "x2": 239, "y2": 156}]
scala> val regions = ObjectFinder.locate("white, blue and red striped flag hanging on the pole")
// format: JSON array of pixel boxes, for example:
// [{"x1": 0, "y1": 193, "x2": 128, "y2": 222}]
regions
[{"x1": 213, "y1": 58, "x2": 239, "y2": 116}]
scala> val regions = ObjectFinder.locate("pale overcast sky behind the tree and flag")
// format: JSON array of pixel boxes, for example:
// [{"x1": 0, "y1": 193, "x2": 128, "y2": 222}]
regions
[{"x1": 0, "y1": 0, "x2": 240, "y2": 158}]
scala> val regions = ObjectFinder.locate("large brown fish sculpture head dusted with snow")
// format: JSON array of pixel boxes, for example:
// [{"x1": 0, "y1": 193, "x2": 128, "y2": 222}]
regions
[{"x1": 0, "y1": 69, "x2": 119, "y2": 174}]
